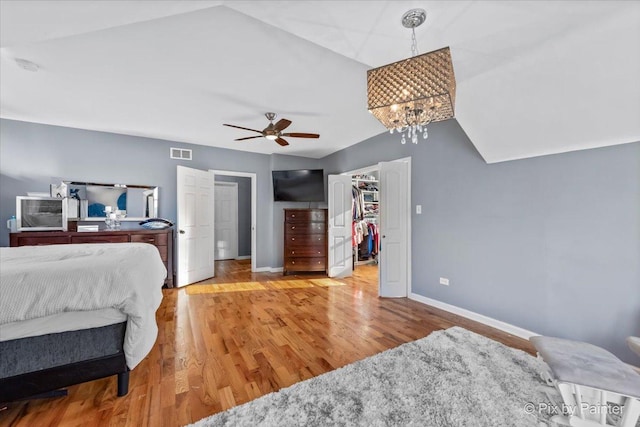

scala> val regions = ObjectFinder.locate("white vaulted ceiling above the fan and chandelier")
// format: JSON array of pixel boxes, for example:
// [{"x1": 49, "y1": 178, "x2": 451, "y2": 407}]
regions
[{"x1": 0, "y1": 0, "x2": 640, "y2": 163}]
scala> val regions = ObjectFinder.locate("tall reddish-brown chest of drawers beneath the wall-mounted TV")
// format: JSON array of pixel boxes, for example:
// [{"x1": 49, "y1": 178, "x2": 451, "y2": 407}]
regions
[{"x1": 283, "y1": 209, "x2": 327, "y2": 274}]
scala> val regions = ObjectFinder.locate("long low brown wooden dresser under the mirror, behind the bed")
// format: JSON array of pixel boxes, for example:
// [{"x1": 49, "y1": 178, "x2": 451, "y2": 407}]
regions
[{"x1": 10, "y1": 228, "x2": 174, "y2": 288}]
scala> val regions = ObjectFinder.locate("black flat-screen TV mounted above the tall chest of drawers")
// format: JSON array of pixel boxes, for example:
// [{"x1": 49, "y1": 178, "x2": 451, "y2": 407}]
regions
[{"x1": 272, "y1": 169, "x2": 324, "y2": 202}]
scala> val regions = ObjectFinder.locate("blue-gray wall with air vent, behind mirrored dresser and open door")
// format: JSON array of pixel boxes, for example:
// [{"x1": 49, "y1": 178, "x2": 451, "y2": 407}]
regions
[{"x1": 0, "y1": 119, "x2": 274, "y2": 268}]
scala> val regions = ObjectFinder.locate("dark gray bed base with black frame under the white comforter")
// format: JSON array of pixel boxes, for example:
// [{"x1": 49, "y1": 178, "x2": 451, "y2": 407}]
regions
[{"x1": 0, "y1": 323, "x2": 129, "y2": 402}]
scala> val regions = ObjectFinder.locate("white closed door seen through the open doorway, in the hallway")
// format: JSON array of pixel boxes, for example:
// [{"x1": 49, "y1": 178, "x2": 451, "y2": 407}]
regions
[{"x1": 214, "y1": 182, "x2": 238, "y2": 260}]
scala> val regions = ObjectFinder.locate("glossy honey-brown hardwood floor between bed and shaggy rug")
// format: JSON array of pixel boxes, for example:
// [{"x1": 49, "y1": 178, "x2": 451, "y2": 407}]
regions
[{"x1": 0, "y1": 260, "x2": 533, "y2": 426}]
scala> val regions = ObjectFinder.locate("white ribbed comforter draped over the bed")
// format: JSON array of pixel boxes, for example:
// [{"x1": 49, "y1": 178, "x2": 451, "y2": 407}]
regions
[{"x1": 0, "y1": 243, "x2": 167, "y2": 369}]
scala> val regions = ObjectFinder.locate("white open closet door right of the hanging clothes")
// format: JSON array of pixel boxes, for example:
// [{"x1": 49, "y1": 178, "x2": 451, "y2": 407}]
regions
[{"x1": 378, "y1": 162, "x2": 410, "y2": 297}]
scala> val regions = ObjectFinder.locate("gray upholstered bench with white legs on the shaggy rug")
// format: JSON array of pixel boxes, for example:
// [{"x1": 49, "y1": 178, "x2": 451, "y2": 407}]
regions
[{"x1": 530, "y1": 336, "x2": 640, "y2": 427}]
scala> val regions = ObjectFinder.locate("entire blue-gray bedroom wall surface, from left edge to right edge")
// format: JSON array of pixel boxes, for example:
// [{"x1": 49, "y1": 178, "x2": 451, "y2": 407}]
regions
[{"x1": 0, "y1": 120, "x2": 640, "y2": 363}]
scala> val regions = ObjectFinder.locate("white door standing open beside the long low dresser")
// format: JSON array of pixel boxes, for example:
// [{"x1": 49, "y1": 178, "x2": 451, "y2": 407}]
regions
[{"x1": 177, "y1": 166, "x2": 215, "y2": 286}]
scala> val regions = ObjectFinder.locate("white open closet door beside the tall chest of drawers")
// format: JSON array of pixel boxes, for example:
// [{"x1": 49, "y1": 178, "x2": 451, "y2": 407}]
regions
[{"x1": 328, "y1": 175, "x2": 353, "y2": 277}]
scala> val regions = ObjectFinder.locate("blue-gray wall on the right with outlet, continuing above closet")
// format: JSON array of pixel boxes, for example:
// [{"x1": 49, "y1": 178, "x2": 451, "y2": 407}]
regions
[{"x1": 323, "y1": 120, "x2": 640, "y2": 364}]
